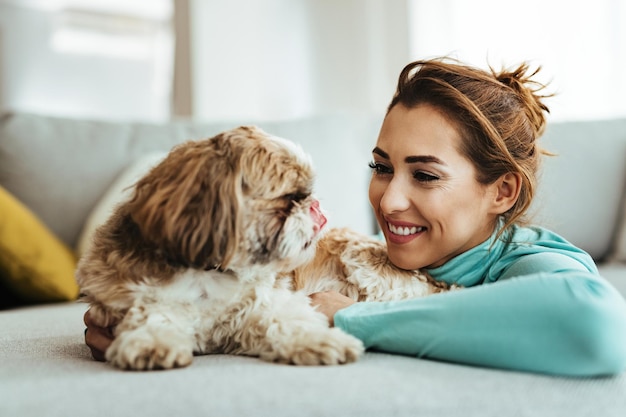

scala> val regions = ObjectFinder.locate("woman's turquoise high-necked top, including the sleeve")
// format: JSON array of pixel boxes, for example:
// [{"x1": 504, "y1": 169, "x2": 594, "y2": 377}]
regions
[{"x1": 334, "y1": 226, "x2": 626, "y2": 376}]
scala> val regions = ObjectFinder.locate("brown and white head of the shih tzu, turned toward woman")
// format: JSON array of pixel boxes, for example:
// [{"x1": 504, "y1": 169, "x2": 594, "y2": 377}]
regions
[{"x1": 127, "y1": 127, "x2": 326, "y2": 270}]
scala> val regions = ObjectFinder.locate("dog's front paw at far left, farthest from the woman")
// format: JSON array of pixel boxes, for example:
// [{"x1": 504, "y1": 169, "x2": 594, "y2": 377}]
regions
[{"x1": 106, "y1": 328, "x2": 193, "y2": 371}]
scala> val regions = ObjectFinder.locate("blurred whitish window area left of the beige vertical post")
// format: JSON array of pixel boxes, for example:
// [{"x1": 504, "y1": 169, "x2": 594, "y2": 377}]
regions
[{"x1": 0, "y1": 0, "x2": 174, "y2": 120}]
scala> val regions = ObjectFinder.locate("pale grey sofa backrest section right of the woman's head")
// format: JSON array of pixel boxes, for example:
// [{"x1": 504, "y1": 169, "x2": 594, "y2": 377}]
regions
[{"x1": 533, "y1": 119, "x2": 626, "y2": 260}]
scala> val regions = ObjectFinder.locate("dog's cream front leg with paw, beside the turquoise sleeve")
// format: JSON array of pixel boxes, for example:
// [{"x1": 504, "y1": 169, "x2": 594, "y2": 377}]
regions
[{"x1": 242, "y1": 290, "x2": 364, "y2": 365}]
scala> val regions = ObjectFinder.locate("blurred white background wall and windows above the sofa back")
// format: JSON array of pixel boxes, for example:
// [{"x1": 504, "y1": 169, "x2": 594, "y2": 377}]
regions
[{"x1": 0, "y1": 0, "x2": 626, "y2": 121}]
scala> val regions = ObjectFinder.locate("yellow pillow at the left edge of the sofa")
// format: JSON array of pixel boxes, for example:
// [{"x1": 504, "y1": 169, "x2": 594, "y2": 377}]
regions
[{"x1": 0, "y1": 187, "x2": 79, "y2": 302}]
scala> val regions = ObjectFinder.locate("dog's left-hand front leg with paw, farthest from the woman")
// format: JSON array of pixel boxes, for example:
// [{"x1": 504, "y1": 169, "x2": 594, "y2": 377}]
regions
[{"x1": 106, "y1": 303, "x2": 194, "y2": 370}]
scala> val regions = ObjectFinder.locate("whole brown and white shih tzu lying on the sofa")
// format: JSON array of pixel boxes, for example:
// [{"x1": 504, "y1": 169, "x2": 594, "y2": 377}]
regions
[{"x1": 76, "y1": 127, "x2": 447, "y2": 370}]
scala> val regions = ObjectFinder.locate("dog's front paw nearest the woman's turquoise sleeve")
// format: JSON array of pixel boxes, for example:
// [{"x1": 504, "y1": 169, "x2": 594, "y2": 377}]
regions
[{"x1": 261, "y1": 328, "x2": 365, "y2": 365}]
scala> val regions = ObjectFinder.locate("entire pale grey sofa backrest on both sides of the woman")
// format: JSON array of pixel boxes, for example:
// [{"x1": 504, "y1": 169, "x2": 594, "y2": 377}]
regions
[{"x1": 0, "y1": 113, "x2": 626, "y2": 259}]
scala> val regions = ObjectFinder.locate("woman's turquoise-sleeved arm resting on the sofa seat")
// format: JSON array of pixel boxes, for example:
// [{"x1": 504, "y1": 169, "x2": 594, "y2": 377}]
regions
[{"x1": 334, "y1": 270, "x2": 626, "y2": 376}]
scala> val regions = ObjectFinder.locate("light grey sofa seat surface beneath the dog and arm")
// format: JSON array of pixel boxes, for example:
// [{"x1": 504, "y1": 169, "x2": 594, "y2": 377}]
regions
[{"x1": 0, "y1": 304, "x2": 626, "y2": 417}]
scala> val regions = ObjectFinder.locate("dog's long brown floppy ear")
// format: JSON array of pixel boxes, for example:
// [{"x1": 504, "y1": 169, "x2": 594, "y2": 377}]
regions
[{"x1": 129, "y1": 135, "x2": 243, "y2": 269}]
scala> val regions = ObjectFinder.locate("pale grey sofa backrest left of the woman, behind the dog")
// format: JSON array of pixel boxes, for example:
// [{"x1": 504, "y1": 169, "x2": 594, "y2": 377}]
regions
[{"x1": 0, "y1": 113, "x2": 380, "y2": 247}]
